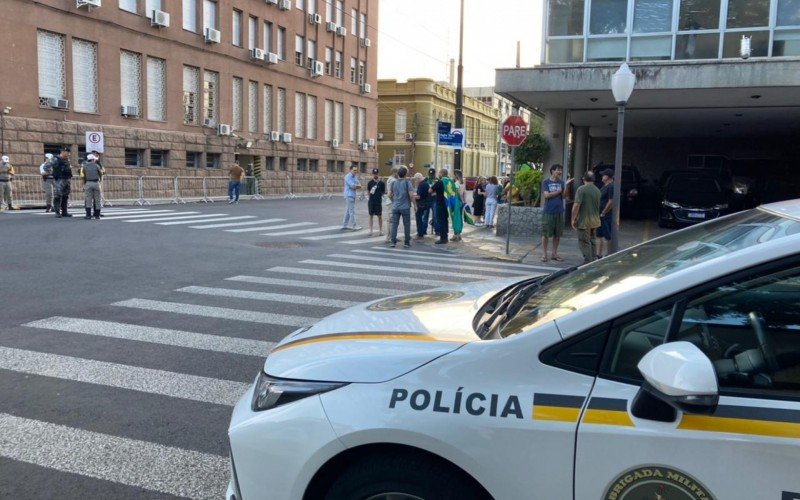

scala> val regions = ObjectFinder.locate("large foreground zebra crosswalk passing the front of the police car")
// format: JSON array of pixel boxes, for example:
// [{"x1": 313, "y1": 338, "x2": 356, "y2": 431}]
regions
[{"x1": 0, "y1": 235, "x2": 550, "y2": 498}]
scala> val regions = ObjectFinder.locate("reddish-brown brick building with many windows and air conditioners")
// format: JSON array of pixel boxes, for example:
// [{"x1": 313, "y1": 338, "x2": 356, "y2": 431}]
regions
[{"x1": 0, "y1": 0, "x2": 378, "y2": 188}]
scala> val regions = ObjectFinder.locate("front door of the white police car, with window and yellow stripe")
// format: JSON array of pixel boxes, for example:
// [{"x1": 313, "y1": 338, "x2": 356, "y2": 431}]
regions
[{"x1": 575, "y1": 262, "x2": 800, "y2": 500}]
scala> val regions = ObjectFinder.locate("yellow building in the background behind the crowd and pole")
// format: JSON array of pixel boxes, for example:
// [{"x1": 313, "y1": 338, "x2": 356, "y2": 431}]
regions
[{"x1": 378, "y1": 78, "x2": 499, "y2": 177}]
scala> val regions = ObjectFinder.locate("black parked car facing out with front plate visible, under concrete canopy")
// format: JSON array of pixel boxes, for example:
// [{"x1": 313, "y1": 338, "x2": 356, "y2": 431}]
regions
[{"x1": 658, "y1": 169, "x2": 731, "y2": 227}]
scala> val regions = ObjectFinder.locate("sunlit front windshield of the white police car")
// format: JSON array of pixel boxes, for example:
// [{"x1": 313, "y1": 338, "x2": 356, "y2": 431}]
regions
[{"x1": 499, "y1": 209, "x2": 800, "y2": 337}]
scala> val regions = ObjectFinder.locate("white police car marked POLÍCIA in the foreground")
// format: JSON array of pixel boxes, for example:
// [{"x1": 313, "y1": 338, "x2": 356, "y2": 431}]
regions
[{"x1": 228, "y1": 201, "x2": 800, "y2": 500}]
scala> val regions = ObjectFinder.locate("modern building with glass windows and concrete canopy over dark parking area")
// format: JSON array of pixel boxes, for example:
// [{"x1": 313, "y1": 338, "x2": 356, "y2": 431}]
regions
[{"x1": 496, "y1": 0, "x2": 800, "y2": 188}]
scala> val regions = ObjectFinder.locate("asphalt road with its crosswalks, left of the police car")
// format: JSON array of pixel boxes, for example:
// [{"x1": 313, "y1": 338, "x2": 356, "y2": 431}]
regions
[{"x1": 0, "y1": 199, "x2": 552, "y2": 499}]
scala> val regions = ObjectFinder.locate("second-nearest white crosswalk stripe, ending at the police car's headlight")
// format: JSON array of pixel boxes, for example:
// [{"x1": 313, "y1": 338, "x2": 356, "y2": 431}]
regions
[{"x1": 0, "y1": 347, "x2": 248, "y2": 406}]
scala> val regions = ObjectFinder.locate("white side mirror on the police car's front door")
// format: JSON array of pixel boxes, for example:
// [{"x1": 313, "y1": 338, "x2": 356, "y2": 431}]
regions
[{"x1": 638, "y1": 342, "x2": 719, "y2": 415}]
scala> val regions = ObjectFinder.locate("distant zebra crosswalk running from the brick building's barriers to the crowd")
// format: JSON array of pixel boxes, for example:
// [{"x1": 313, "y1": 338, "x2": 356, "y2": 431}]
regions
[{"x1": 25, "y1": 207, "x2": 475, "y2": 245}]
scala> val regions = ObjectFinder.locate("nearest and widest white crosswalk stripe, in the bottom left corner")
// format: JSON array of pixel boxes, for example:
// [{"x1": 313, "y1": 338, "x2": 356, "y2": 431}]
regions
[{"x1": 0, "y1": 413, "x2": 230, "y2": 499}]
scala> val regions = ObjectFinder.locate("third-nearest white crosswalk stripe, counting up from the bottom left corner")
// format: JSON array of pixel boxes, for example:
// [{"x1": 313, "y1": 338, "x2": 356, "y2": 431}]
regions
[{"x1": 23, "y1": 316, "x2": 275, "y2": 357}]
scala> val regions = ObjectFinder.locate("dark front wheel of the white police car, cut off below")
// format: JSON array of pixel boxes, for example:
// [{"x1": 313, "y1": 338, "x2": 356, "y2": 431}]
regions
[{"x1": 325, "y1": 452, "x2": 484, "y2": 500}]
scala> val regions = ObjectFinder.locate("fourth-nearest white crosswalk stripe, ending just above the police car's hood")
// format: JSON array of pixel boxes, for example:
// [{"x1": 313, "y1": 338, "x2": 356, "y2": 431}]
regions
[{"x1": 111, "y1": 299, "x2": 319, "y2": 327}]
